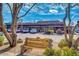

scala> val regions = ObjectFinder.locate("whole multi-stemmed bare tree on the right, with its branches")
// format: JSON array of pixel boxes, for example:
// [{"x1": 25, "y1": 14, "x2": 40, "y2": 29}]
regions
[{"x1": 63, "y1": 3, "x2": 79, "y2": 48}]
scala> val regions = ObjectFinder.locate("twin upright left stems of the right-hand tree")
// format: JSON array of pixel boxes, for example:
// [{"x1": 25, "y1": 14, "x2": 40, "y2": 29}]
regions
[{"x1": 63, "y1": 3, "x2": 72, "y2": 48}]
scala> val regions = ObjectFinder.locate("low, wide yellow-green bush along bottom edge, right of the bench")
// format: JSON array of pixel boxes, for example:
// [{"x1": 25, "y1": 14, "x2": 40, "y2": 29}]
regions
[{"x1": 44, "y1": 47, "x2": 79, "y2": 56}]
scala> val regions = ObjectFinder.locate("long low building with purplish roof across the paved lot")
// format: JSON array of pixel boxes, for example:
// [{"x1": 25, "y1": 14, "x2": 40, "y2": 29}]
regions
[{"x1": 3, "y1": 21, "x2": 64, "y2": 32}]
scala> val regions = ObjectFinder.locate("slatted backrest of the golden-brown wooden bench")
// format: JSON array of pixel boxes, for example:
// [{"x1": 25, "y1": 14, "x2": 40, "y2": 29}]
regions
[{"x1": 24, "y1": 37, "x2": 52, "y2": 48}]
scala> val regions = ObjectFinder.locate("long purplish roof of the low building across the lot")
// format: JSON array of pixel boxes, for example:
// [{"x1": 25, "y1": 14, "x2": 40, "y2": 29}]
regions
[{"x1": 7, "y1": 21, "x2": 64, "y2": 27}]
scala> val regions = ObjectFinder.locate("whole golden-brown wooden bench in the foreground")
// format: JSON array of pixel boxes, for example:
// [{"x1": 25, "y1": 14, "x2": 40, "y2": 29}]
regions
[{"x1": 21, "y1": 37, "x2": 52, "y2": 54}]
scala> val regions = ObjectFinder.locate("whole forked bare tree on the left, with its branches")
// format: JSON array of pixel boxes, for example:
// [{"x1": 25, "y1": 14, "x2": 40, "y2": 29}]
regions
[{"x1": 0, "y1": 3, "x2": 36, "y2": 47}]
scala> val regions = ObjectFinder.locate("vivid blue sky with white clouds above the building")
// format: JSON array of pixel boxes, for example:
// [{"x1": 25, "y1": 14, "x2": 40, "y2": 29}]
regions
[{"x1": 3, "y1": 3, "x2": 79, "y2": 24}]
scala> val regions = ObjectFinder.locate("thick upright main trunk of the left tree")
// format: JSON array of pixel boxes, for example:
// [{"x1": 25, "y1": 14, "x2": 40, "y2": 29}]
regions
[{"x1": 11, "y1": 3, "x2": 18, "y2": 47}]
